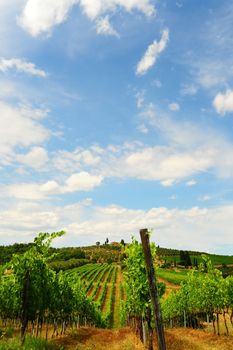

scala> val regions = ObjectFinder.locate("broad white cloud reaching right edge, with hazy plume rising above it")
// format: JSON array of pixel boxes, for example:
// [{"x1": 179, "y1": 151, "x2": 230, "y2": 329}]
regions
[{"x1": 52, "y1": 100, "x2": 233, "y2": 186}]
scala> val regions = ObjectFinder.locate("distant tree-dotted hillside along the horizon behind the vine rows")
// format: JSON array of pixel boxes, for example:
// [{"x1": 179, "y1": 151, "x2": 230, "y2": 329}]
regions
[{"x1": 0, "y1": 242, "x2": 233, "y2": 270}]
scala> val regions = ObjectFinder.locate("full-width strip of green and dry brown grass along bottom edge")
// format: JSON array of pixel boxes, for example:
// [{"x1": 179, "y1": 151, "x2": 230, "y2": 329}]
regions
[{"x1": 0, "y1": 327, "x2": 233, "y2": 350}]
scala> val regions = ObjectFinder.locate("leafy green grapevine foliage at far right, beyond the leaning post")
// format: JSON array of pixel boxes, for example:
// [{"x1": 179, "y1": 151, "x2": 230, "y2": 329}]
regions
[{"x1": 162, "y1": 256, "x2": 233, "y2": 333}]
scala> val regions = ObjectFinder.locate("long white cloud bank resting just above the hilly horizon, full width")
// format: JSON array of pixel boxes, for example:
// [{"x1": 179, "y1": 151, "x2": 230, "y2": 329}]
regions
[{"x1": 0, "y1": 200, "x2": 233, "y2": 254}]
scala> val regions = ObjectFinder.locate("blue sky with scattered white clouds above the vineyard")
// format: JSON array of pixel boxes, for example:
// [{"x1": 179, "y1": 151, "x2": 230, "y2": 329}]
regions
[{"x1": 0, "y1": 0, "x2": 233, "y2": 255}]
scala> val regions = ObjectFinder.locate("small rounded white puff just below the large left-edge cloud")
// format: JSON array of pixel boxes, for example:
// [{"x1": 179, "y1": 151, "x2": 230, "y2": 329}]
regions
[{"x1": 16, "y1": 147, "x2": 49, "y2": 169}]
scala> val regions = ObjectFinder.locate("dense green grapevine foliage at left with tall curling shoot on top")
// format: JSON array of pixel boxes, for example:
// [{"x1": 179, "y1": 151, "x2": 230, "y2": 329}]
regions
[{"x1": 0, "y1": 231, "x2": 102, "y2": 334}]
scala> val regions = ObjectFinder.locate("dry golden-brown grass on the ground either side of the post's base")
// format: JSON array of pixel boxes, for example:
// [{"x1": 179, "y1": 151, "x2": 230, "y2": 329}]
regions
[{"x1": 51, "y1": 328, "x2": 233, "y2": 350}]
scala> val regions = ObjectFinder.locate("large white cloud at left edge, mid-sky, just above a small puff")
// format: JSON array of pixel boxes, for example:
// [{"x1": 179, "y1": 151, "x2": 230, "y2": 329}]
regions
[{"x1": 0, "y1": 101, "x2": 51, "y2": 164}]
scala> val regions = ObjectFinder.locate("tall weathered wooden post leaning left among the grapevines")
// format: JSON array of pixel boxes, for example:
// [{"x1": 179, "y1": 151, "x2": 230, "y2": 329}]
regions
[{"x1": 140, "y1": 229, "x2": 166, "y2": 350}]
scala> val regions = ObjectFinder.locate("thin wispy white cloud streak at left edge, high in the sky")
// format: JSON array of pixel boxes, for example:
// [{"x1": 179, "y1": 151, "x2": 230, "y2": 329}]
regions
[{"x1": 0, "y1": 58, "x2": 47, "y2": 78}]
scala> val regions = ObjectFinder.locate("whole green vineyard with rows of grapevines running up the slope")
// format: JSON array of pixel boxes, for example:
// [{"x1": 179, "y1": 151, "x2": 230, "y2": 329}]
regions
[{"x1": 0, "y1": 232, "x2": 233, "y2": 349}]
